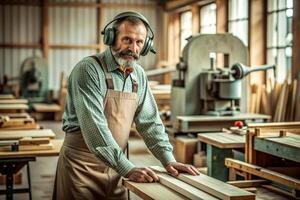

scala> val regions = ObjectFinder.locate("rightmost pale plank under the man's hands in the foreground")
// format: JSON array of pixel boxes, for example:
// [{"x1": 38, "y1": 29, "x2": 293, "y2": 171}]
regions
[{"x1": 151, "y1": 166, "x2": 255, "y2": 200}]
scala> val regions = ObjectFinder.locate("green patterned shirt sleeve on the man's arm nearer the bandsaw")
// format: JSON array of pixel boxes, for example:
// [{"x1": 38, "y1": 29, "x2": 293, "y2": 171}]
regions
[{"x1": 134, "y1": 71, "x2": 176, "y2": 166}]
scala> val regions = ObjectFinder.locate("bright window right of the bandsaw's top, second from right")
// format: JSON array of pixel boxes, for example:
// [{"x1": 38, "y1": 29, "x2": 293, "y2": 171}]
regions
[{"x1": 228, "y1": 0, "x2": 249, "y2": 46}]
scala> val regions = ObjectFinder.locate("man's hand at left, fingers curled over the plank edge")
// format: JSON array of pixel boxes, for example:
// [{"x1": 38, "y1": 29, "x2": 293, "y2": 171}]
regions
[{"x1": 126, "y1": 167, "x2": 159, "y2": 183}]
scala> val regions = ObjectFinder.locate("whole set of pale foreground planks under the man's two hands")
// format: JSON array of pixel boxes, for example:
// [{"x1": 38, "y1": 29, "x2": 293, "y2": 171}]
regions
[{"x1": 123, "y1": 166, "x2": 255, "y2": 200}]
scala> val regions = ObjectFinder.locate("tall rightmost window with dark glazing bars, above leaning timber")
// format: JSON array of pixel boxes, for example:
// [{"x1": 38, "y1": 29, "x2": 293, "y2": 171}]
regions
[{"x1": 267, "y1": 0, "x2": 293, "y2": 83}]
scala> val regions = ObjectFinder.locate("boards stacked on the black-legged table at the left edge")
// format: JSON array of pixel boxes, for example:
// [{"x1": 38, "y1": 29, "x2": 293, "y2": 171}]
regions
[{"x1": 0, "y1": 129, "x2": 55, "y2": 152}]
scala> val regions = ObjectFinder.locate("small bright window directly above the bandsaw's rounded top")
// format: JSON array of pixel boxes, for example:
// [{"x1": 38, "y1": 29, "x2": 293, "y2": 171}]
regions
[{"x1": 200, "y1": 3, "x2": 217, "y2": 33}]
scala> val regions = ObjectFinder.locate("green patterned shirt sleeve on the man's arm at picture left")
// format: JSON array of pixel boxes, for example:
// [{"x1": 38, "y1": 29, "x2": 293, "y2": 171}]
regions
[{"x1": 68, "y1": 61, "x2": 134, "y2": 176}]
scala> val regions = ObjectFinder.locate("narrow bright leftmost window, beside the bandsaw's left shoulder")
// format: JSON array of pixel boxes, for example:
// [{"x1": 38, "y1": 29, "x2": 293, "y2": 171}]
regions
[{"x1": 180, "y1": 11, "x2": 192, "y2": 51}]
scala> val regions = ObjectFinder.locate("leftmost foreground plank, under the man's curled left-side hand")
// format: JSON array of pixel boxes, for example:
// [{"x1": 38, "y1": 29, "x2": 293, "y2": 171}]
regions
[{"x1": 122, "y1": 179, "x2": 188, "y2": 200}]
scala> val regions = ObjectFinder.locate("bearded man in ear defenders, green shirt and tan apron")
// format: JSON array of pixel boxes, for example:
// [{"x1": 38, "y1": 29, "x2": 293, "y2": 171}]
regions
[{"x1": 53, "y1": 12, "x2": 199, "y2": 199}]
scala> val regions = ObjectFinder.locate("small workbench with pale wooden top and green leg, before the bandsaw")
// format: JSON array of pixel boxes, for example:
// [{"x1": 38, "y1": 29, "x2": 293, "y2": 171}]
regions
[{"x1": 198, "y1": 132, "x2": 245, "y2": 181}]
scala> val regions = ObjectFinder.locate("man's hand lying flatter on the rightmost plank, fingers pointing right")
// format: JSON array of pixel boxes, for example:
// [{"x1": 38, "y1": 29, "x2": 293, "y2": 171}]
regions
[{"x1": 165, "y1": 162, "x2": 200, "y2": 176}]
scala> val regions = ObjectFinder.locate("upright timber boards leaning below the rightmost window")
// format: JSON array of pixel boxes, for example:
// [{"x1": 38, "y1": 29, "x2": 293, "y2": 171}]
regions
[{"x1": 250, "y1": 79, "x2": 300, "y2": 122}]
